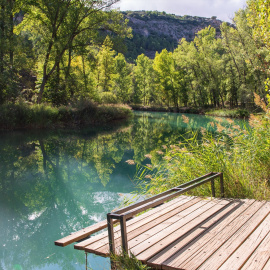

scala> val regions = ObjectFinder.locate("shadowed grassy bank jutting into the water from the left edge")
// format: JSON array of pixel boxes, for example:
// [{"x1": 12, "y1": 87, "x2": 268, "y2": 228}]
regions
[{"x1": 0, "y1": 101, "x2": 132, "y2": 130}]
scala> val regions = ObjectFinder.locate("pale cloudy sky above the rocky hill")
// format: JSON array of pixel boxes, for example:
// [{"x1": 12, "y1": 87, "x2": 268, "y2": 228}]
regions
[{"x1": 115, "y1": 0, "x2": 246, "y2": 22}]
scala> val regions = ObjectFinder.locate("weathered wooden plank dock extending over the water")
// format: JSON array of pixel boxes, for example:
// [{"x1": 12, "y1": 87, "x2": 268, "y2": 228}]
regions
[{"x1": 55, "y1": 174, "x2": 270, "y2": 270}]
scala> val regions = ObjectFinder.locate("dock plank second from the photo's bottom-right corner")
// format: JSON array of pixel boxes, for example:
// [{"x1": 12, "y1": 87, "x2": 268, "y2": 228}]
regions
[{"x1": 241, "y1": 228, "x2": 270, "y2": 270}]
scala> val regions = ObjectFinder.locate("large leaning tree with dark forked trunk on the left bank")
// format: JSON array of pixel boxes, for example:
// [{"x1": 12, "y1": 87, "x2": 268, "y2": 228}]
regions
[{"x1": 18, "y1": 0, "x2": 130, "y2": 103}]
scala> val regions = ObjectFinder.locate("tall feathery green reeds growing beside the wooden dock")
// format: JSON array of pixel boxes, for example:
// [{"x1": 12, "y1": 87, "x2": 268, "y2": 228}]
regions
[{"x1": 137, "y1": 94, "x2": 270, "y2": 200}]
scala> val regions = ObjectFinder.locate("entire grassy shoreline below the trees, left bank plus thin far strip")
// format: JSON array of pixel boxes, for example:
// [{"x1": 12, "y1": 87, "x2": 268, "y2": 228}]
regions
[{"x1": 0, "y1": 100, "x2": 258, "y2": 130}]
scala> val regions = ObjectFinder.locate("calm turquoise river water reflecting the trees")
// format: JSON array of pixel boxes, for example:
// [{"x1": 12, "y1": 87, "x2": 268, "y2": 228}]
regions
[{"x1": 0, "y1": 112, "x2": 245, "y2": 270}]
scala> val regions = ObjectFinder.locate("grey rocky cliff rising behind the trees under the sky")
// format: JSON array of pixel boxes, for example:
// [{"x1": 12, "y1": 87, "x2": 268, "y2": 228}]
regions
[{"x1": 123, "y1": 11, "x2": 222, "y2": 59}]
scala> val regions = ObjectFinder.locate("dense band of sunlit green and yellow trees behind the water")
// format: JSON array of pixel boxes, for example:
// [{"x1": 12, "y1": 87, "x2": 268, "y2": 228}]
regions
[{"x1": 0, "y1": 0, "x2": 269, "y2": 108}]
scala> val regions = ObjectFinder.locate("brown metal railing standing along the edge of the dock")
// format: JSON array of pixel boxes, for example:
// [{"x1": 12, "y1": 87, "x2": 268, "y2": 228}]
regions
[{"x1": 107, "y1": 172, "x2": 224, "y2": 254}]
